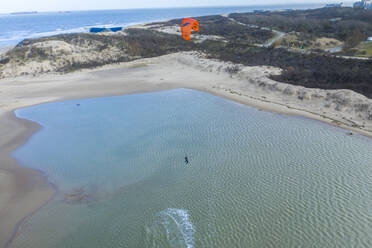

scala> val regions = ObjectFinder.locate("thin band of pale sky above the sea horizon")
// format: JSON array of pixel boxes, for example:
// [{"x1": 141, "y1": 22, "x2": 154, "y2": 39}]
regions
[{"x1": 0, "y1": 0, "x2": 348, "y2": 13}]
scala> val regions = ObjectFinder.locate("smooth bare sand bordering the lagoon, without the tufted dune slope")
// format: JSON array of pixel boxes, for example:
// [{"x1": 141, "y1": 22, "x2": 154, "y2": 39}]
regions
[{"x1": 0, "y1": 53, "x2": 372, "y2": 247}]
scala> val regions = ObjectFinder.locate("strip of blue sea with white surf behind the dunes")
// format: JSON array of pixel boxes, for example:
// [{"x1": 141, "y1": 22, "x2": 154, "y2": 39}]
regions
[{"x1": 0, "y1": 3, "x2": 324, "y2": 47}]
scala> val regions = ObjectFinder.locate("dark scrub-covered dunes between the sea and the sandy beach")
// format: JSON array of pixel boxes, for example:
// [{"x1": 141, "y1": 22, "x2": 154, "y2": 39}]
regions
[{"x1": 0, "y1": 8, "x2": 372, "y2": 98}]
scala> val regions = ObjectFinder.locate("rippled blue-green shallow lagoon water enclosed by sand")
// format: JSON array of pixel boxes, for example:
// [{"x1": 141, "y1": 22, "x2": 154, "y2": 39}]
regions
[{"x1": 11, "y1": 89, "x2": 372, "y2": 248}]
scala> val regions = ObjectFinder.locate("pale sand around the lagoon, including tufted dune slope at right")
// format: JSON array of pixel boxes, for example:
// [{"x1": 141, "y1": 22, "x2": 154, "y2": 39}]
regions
[{"x1": 0, "y1": 52, "x2": 372, "y2": 246}]
